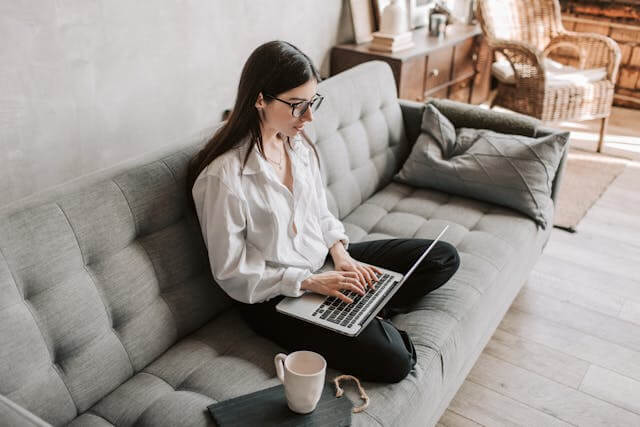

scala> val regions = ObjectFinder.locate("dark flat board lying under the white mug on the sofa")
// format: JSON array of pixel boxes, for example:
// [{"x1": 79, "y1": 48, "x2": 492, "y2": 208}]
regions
[{"x1": 208, "y1": 383, "x2": 353, "y2": 427}]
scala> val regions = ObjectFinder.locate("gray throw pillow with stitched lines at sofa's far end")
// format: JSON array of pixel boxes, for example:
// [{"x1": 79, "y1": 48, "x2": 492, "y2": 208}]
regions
[{"x1": 394, "y1": 105, "x2": 569, "y2": 228}]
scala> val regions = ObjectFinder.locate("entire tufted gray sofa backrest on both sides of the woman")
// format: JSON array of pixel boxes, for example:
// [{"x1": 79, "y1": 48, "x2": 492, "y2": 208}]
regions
[{"x1": 0, "y1": 62, "x2": 407, "y2": 424}]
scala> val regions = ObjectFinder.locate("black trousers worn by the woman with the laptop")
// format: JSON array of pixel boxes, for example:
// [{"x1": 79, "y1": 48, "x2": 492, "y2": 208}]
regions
[{"x1": 236, "y1": 239, "x2": 460, "y2": 383}]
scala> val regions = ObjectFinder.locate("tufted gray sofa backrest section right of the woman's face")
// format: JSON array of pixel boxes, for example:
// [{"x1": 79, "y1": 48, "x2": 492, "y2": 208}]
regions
[{"x1": 307, "y1": 61, "x2": 409, "y2": 219}]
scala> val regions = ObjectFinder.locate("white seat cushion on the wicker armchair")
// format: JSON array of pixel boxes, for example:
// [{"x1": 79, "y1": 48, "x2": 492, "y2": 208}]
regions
[{"x1": 491, "y1": 58, "x2": 607, "y2": 86}]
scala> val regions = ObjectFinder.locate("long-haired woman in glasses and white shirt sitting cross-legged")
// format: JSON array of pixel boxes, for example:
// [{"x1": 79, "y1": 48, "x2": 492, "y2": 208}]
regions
[{"x1": 187, "y1": 41, "x2": 459, "y2": 382}]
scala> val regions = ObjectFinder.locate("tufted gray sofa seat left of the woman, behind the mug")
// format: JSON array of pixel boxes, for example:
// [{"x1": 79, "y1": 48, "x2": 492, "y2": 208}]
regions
[{"x1": 72, "y1": 309, "x2": 282, "y2": 426}]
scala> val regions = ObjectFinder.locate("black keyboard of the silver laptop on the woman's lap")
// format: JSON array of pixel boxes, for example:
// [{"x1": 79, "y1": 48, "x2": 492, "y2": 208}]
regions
[{"x1": 311, "y1": 273, "x2": 394, "y2": 328}]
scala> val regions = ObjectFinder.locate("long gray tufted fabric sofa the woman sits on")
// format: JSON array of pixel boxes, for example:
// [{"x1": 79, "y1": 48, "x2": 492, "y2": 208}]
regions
[{"x1": 0, "y1": 62, "x2": 564, "y2": 426}]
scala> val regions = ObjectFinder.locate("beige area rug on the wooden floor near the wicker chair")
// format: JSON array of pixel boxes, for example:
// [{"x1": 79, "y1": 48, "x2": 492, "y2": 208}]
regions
[{"x1": 554, "y1": 149, "x2": 628, "y2": 232}]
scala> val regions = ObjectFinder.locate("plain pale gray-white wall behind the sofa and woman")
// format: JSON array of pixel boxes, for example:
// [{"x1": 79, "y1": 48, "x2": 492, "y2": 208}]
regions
[{"x1": 0, "y1": 0, "x2": 352, "y2": 206}]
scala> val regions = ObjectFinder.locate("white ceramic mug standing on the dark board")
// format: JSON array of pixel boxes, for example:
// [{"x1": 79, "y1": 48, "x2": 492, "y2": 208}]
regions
[{"x1": 274, "y1": 351, "x2": 327, "y2": 414}]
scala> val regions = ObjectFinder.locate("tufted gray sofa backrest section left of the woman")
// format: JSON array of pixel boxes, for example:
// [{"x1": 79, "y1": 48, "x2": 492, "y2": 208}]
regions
[{"x1": 0, "y1": 141, "x2": 231, "y2": 424}]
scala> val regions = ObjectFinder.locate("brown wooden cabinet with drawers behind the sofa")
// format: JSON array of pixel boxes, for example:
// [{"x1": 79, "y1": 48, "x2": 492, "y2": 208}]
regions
[{"x1": 331, "y1": 25, "x2": 491, "y2": 104}]
